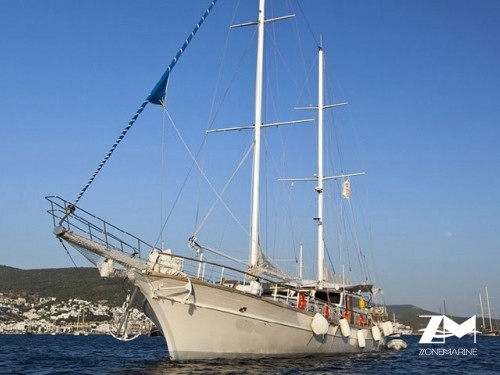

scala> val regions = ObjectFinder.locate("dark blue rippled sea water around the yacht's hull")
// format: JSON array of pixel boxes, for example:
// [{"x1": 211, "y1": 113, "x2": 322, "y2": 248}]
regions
[{"x1": 0, "y1": 335, "x2": 500, "y2": 375}]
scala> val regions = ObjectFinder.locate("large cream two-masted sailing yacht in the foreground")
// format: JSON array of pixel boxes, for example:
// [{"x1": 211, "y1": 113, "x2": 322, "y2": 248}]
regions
[{"x1": 47, "y1": 0, "x2": 392, "y2": 360}]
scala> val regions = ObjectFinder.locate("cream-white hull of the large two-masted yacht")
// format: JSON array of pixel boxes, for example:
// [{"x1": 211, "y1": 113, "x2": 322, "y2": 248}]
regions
[{"x1": 134, "y1": 273, "x2": 385, "y2": 360}]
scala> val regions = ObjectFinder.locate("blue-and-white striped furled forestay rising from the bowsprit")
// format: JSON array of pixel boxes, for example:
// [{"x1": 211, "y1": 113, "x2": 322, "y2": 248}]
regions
[{"x1": 69, "y1": 0, "x2": 217, "y2": 209}]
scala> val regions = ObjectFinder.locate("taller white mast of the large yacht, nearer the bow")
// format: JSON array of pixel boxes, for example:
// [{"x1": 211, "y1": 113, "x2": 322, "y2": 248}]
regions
[{"x1": 250, "y1": 0, "x2": 266, "y2": 267}]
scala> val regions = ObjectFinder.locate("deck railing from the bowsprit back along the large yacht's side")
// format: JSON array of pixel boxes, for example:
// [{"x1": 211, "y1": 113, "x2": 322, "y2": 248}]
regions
[{"x1": 46, "y1": 196, "x2": 371, "y2": 325}]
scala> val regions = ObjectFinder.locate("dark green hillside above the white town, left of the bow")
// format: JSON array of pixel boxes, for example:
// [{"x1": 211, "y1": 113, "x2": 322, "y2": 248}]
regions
[{"x1": 0, "y1": 265, "x2": 126, "y2": 306}]
